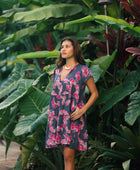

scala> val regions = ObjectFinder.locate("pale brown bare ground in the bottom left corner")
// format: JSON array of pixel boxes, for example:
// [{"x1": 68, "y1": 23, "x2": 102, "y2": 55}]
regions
[{"x1": 0, "y1": 142, "x2": 20, "y2": 170}]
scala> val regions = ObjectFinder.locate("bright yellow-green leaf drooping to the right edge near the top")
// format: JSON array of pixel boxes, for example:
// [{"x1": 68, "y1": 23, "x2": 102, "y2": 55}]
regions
[{"x1": 94, "y1": 15, "x2": 140, "y2": 37}]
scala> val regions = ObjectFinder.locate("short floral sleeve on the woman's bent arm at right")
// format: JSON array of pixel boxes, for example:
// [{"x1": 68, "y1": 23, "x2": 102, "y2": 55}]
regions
[{"x1": 82, "y1": 66, "x2": 93, "y2": 83}]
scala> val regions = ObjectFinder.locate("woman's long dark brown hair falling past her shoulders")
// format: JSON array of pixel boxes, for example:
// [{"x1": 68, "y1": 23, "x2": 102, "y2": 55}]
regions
[{"x1": 56, "y1": 37, "x2": 85, "y2": 68}]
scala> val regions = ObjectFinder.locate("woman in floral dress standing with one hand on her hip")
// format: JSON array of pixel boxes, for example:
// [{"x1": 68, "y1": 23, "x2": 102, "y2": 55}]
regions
[{"x1": 46, "y1": 37, "x2": 98, "y2": 170}]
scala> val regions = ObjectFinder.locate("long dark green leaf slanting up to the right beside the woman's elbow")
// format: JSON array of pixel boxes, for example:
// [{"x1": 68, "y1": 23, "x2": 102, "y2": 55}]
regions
[{"x1": 98, "y1": 71, "x2": 140, "y2": 115}]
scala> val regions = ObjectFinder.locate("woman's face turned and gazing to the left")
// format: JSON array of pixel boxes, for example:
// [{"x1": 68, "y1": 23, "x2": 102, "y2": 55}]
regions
[{"x1": 60, "y1": 40, "x2": 74, "y2": 59}]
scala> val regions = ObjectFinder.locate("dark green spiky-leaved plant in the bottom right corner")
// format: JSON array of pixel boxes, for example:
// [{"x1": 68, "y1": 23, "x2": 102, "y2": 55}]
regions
[{"x1": 95, "y1": 125, "x2": 140, "y2": 170}]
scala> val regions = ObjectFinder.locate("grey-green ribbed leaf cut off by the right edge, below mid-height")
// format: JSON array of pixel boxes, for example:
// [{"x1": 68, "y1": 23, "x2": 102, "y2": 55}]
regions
[{"x1": 125, "y1": 91, "x2": 140, "y2": 126}]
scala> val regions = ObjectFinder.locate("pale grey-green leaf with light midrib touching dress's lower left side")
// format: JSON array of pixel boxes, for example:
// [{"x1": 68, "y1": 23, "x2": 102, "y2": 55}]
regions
[{"x1": 13, "y1": 107, "x2": 48, "y2": 136}]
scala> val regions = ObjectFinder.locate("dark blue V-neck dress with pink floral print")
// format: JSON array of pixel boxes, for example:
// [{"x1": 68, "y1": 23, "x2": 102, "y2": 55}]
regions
[{"x1": 46, "y1": 64, "x2": 92, "y2": 151}]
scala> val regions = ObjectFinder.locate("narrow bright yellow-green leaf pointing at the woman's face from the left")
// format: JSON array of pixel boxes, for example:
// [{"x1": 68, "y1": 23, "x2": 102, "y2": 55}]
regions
[{"x1": 17, "y1": 51, "x2": 60, "y2": 58}]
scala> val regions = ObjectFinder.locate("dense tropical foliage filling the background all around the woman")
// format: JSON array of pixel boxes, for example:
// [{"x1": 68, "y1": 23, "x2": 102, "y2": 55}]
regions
[{"x1": 0, "y1": 0, "x2": 140, "y2": 170}]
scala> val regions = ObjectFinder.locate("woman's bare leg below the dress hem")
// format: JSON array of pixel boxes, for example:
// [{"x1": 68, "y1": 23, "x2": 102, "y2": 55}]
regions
[{"x1": 64, "y1": 147, "x2": 75, "y2": 170}]
